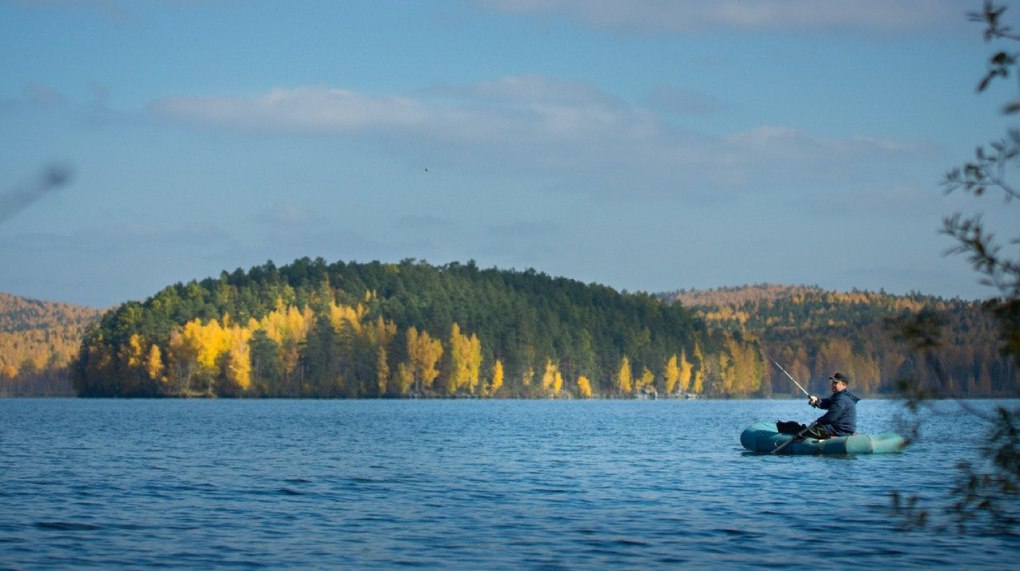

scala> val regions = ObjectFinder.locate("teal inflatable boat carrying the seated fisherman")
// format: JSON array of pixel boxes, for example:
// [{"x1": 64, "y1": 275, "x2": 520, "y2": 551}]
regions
[{"x1": 741, "y1": 421, "x2": 907, "y2": 455}]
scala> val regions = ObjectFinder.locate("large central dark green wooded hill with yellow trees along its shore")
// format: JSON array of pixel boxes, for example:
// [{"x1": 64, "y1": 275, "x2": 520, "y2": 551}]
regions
[{"x1": 74, "y1": 259, "x2": 734, "y2": 398}]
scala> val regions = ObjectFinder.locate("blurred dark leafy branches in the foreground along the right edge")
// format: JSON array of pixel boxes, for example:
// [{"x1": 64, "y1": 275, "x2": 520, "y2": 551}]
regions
[{"x1": 890, "y1": 0, "x2": 1020, "y2": 533}]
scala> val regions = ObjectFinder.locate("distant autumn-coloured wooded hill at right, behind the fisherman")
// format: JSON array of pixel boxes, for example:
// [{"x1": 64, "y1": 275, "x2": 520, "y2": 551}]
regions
[{"x1": 662, "y1": 284, "x2": 1020, "y2": 397}]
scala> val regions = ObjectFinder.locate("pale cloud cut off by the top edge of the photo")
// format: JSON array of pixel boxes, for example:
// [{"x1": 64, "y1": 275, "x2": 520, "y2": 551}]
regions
[{"x1": 479, "y1": 0, "x2": 969, "y2": 34}]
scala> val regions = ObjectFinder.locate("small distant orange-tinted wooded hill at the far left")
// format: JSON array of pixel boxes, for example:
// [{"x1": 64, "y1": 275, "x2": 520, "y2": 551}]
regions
[{"x1": 0, "y1": 294, "x2": 101, "y2": 395}]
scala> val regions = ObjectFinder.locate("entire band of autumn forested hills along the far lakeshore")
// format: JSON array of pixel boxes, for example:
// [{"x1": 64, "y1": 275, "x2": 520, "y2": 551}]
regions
[{"x1": 0, "y1": 259, "x2": 1020, "y2": 398}]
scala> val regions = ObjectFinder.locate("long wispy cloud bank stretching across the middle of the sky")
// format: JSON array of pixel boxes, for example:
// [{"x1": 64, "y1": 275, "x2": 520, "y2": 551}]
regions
[{"x1": 151, "y1": 75, "x2": 926, "y2": 196}]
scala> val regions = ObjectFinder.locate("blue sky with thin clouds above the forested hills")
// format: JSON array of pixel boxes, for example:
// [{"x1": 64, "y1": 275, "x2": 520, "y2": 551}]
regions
[{"x1": 0, "y1": 0, "x2": 1020, "y2": 307}]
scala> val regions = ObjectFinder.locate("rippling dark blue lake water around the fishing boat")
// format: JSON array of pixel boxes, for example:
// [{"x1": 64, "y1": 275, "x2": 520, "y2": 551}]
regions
[{"x1": 0, "y1": 399, "x2": 1020, "y2": 569}]
